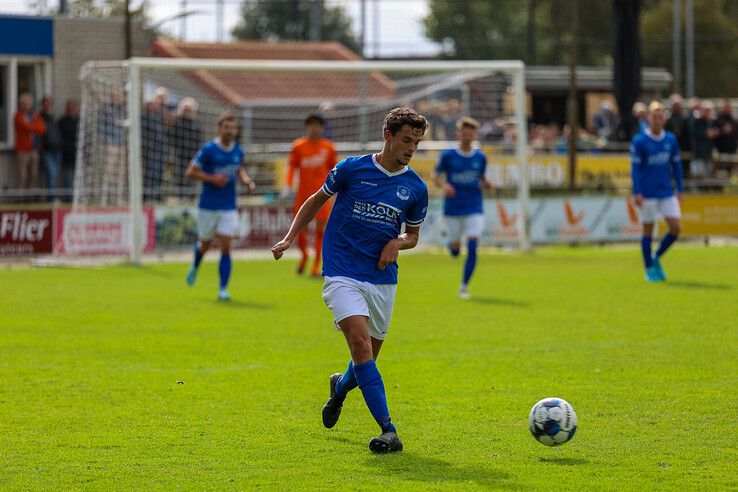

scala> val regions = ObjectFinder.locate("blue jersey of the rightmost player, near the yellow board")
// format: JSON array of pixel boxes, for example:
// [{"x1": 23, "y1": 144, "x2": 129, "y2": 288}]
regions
[{"x1": 630, "y1": 130, "x2": 683, "y2": 198}]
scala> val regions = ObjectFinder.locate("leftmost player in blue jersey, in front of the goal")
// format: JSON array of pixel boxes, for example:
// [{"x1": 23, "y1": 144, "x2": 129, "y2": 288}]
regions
[{"x1": 185, "y1": 113, "x2": 254, "y2": 301}]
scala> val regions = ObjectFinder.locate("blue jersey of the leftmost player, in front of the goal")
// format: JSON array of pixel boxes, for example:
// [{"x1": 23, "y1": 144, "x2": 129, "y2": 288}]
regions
[{"x1": 192, "y1": 139, "x2": 244, "y2": 210}]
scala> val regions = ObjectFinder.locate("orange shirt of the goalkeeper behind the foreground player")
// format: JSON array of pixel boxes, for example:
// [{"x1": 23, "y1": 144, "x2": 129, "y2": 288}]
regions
[{"x1": 287, "y1": 137, "x2": 338, "y2": 204}]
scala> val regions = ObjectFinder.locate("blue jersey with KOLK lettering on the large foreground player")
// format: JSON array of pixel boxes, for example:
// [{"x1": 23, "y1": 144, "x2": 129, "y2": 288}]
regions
[{"x1": 322, "y1": 154, "x2": 428, "y2": 284}]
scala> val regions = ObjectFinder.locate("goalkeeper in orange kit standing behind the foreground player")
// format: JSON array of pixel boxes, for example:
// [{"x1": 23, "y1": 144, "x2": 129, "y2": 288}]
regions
[{"x1": 287, "y1": 114, "x2": 338, "y2": 277}]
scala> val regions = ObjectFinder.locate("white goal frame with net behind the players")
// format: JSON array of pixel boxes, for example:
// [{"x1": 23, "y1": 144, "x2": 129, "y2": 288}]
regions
[{"x1": 72, "y1": 58, "x2": 531, "y2": 263}]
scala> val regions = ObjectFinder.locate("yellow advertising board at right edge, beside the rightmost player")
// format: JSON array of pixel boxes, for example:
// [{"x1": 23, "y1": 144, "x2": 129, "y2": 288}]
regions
[{"x1": 682, "y1": 195, "x2": 738, "y2": 236}]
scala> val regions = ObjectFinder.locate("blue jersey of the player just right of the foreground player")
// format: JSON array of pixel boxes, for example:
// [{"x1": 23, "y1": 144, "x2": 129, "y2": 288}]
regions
[{"x1": 436, "y1": 149, "x2": 487, "y2": 217}]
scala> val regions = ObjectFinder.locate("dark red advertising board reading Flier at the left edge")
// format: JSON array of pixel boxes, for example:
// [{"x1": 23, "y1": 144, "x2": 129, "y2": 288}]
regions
[{"x1": 0, "y1": 210, "x2": 53, "y2": 256}]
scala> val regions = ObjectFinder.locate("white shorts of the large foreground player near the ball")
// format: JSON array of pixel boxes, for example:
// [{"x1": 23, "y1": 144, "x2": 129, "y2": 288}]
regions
[{"x1": 323, "y1": 277, "x2": 397, "y2": 340}]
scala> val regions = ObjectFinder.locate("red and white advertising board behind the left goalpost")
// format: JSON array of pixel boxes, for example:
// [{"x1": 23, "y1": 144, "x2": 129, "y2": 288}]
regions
[{"x1": 56, "y1": 207, "x2": 156, "y2": 255}]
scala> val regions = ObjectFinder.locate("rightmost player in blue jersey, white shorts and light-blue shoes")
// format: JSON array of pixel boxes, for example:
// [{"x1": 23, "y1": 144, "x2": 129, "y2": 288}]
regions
[{"x1": 630, "y1": 101, "x2": 684, "y2": 282}]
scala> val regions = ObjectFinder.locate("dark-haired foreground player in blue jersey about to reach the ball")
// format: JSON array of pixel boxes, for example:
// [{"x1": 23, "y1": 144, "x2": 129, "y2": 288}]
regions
[{"x1": 272, "y1": 108, "x2": 428, "y2": 453}]
